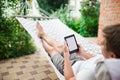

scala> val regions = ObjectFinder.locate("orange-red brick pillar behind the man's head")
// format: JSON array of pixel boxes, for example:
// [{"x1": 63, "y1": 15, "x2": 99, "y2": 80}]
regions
[{"x1": 98, "y1": 0, "x2": 120, "y2": 44}]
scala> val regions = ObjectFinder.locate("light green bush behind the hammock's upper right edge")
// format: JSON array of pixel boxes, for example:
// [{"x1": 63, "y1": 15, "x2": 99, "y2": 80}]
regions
[{"x1": 52, "y1": 6, "x2": 80, "y2": 33}]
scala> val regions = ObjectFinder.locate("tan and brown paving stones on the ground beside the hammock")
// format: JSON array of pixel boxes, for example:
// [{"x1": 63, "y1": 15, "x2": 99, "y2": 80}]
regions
[{"x1": 0, "y1": 52, "x2": 58, "y2": 80}]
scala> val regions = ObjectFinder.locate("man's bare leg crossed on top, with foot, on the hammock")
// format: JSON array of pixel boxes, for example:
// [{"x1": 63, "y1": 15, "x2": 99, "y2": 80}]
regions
[{"x1": 36, "y1": 22, "x2": 63, "y2": 53}]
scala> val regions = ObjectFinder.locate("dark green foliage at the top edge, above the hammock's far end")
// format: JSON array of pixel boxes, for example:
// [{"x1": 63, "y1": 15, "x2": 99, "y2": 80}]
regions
[{"x1": 37, "y1": 0, "x2": 69, "y2": 13}]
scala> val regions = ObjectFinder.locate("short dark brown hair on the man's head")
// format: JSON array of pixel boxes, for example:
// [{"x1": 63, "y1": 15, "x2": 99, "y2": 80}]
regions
[{"x1": 103, "y1": 24, "x2": 120, "y2": 58}]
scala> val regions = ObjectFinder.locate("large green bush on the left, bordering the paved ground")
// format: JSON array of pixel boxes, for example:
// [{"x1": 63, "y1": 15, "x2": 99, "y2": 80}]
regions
[{"x1": 0, "y1": 2, "x2": 36, "y2": 60}]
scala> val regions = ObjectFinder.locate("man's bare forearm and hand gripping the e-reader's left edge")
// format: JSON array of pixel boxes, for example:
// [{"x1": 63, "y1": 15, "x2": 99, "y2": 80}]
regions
[{"x1": 64, "y1": 44, "x2": 75, "y2": 80}]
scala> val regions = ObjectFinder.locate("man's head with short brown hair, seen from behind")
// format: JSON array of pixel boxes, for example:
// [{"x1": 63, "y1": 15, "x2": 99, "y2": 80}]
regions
[{"x1": 102, "y1": 24, "x2": 120, "y2": 58}]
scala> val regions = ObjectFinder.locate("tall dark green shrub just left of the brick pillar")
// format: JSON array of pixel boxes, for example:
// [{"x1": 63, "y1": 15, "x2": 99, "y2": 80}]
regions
[{"x1": 80, "y1": 0, "x2": 100, "y2": 37}]
